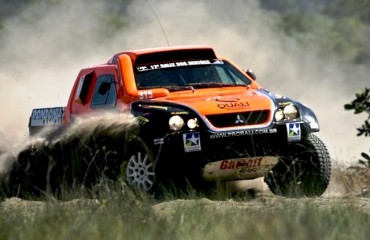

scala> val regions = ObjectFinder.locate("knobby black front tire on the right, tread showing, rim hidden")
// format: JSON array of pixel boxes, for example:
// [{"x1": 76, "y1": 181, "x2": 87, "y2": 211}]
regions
[{"x1": 265, "y1": 134, "x2": 331, "y2": 197}]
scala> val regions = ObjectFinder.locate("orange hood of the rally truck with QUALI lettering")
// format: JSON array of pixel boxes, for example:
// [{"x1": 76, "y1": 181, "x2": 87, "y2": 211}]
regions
[{"x1": 158, "y1": 88, "x2": 274, "y2": 115}]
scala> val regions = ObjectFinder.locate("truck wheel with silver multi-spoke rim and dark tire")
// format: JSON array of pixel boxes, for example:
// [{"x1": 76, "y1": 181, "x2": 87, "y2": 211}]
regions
[{"x1": 119, "y1": 137, "x2": 157, "y2": 194}]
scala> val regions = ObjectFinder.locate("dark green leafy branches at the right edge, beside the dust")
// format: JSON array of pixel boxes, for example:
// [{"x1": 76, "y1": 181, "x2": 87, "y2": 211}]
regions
[{"x1": 344, "y1": 88, "x2": 370, "y2": 167}]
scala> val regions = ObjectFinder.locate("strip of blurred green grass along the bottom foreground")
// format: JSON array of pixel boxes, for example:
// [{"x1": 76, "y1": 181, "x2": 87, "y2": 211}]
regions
[{"x1": 0, "y1": 184, "x2": 370, "y2": 240}]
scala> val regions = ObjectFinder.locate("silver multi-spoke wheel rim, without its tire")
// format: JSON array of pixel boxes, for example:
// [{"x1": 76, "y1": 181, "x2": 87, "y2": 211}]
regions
[{"x1": 126, "y1": 152, "x2": 155, "y2": 192}]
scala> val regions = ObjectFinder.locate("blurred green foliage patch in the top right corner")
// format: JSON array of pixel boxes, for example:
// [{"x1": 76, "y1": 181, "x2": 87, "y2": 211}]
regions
[{"x1": 260, "y1": 0, "x2": 370, "y2": 64}]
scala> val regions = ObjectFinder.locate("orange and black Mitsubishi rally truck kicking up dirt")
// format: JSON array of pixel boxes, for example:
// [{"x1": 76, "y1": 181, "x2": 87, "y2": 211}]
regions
[{"x1": 13, "y1": 46, "x2": 331, "y2": 196}]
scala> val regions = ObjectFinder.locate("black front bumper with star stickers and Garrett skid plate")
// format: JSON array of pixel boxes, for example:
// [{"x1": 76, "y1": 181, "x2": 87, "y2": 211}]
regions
[{"x1": 155, "y1": 121, "x2": 309, "y2": 183}]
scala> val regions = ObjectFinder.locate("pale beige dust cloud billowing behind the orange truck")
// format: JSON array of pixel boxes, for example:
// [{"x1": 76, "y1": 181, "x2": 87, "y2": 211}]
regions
[{"x1": 0, "y1": 0, "x2": 370, "y2": 168}]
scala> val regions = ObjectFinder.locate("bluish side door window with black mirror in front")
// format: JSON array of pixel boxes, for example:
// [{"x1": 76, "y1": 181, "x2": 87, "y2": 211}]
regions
[{"x1": 91, "y1": 75, "x2": 117, "y2": 108}]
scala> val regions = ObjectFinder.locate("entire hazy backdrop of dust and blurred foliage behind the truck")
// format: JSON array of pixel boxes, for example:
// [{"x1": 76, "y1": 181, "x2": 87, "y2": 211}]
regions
[{"x1": 0, "y1": 0, "x2": 370, "y2": 165}]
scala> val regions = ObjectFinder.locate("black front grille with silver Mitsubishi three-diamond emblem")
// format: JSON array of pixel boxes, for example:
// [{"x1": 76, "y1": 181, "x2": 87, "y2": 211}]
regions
[{"x1": 206, "y1": 110, "x2": 269, "y2": 128}]
